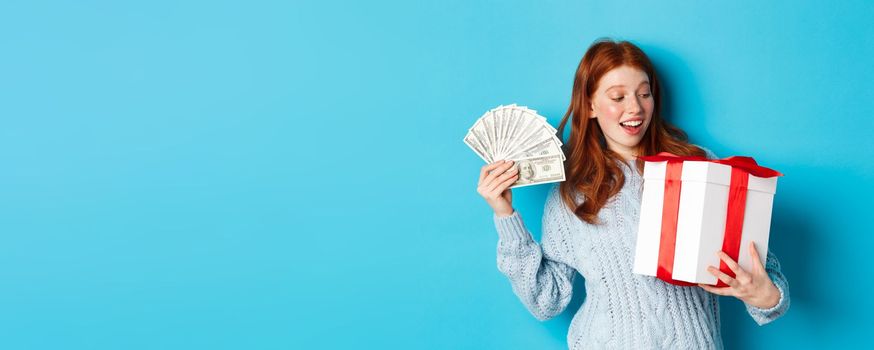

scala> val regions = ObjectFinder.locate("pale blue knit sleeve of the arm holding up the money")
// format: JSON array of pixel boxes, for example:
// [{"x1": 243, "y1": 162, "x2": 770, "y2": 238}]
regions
[{"x1": 494, "y1": 187, "x2": 576, "y2": 321}]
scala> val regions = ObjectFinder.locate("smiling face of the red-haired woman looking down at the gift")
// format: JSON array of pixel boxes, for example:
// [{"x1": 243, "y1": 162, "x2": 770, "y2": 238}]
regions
[{"x1": 591, "y1": 66, "x2": 655, "y2": 159}]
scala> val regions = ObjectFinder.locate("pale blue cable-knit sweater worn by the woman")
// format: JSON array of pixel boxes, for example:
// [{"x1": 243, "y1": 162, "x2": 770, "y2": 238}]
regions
[{"x1": 493, "y1": 149, "x2": 789, "y2": 349}]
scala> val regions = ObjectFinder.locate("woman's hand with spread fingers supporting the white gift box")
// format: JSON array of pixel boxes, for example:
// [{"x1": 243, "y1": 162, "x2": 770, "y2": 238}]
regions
[{"x1": 698, "y1": 242, "x2": 780, "y2": 309}]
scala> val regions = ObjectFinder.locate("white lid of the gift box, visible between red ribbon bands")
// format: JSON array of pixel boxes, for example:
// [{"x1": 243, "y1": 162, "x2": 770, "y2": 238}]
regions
[{"x1": 643, "y1": 160, "x2": 777, "y2": 194}]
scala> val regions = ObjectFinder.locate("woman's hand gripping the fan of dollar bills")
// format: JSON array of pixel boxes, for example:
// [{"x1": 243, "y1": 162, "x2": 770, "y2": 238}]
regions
[{"x1": 476, "y1": 160, "x2": 519, "y2": 216}]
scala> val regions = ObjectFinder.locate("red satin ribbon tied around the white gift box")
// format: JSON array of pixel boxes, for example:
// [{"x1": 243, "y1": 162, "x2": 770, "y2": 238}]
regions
[{"x1": 639, "y1": 152, "x2": 783, "y2": 287}]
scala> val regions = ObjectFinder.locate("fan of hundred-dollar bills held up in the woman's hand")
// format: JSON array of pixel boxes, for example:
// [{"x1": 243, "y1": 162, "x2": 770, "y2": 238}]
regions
[{"x1": 464, "y1": 103, "x2": 565, "y2": 188}]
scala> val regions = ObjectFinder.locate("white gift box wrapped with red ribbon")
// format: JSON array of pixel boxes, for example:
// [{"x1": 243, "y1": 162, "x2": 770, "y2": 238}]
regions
[{"x1": 633, "y1": 154, "x2": 781, "y2": 285}]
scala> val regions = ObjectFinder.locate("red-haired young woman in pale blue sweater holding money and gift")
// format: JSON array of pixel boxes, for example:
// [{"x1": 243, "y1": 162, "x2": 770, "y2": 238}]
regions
[{"x1": 477, "y1": 40, "x2": 789, "y2": 349}]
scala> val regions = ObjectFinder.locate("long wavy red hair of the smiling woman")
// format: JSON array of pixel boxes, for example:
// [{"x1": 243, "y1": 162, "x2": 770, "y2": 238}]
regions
[{"x1": 558, "y1": 39, "x2": 706, "y2": 224}]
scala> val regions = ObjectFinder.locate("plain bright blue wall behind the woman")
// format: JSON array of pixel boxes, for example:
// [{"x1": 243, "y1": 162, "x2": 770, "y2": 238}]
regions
[{"x1": 0, "y1": 0, "x2": 874, "y2": 349}]
